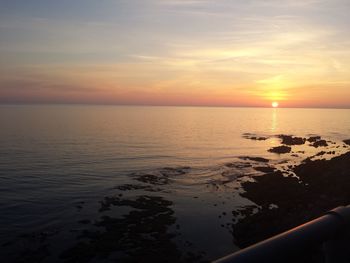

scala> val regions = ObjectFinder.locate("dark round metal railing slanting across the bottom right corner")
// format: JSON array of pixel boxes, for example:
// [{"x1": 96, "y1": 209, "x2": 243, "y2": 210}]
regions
[{"x1": 214, "y1": 206, "x2": 350, "y2": 263}]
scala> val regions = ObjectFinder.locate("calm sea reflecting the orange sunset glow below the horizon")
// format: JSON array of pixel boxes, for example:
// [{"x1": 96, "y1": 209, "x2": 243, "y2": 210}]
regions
[{"x1": 0, "y1": 105, "x2": 350, "y2": 262}]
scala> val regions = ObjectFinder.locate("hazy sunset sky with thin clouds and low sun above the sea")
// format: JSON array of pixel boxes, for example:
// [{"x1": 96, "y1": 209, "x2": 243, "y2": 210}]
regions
[{"x1": 0, "y1": 0, "x2": 350, "y2": 108}]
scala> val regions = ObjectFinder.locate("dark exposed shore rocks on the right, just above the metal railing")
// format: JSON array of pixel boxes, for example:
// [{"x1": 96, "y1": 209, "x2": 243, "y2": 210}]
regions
[{"x1": 232, "y1": 137, "x2": 350, "y2": 262}]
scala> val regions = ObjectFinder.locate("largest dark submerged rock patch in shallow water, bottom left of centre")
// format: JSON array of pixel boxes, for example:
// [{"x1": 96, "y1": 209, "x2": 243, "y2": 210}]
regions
[{"x1": 61, "y1": 196, "x2": 182, "y2": 263}]
